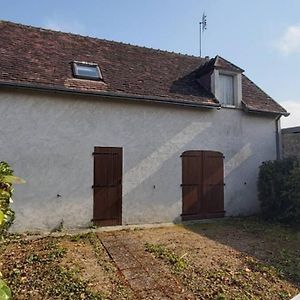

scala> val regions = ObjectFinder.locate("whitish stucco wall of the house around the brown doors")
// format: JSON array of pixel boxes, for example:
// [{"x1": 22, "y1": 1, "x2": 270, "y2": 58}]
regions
[{"x1": 0, "y1": 90, "x2": 276, "y2": 231}]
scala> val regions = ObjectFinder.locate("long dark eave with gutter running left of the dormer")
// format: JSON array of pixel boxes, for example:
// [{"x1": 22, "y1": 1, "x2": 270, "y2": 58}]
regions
[{"x1": 0, "y1": 81, "x2": 221, "y2": 109}]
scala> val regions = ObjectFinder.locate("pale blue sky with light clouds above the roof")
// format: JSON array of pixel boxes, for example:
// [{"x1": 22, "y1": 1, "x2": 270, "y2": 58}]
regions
[{"x1": 0, "y1": 0, "x2": 300, "y2": 127}]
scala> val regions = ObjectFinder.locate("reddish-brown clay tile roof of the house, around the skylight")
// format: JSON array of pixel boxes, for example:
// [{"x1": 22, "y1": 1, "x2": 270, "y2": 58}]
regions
[{"x1": 0, "y1": 21, "x2": 285, "y2": 113}]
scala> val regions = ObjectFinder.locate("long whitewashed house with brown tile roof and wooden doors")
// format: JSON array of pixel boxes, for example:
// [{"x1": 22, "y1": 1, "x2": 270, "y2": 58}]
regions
[{"x1": 0, "y1": 21, "x2": 287, "y2": 231}]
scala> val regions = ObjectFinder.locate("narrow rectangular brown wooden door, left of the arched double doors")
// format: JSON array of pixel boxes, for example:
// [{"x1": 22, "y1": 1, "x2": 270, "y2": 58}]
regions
[{"x1": 93, "y1": 147, "x2": 122, "y2": 226}]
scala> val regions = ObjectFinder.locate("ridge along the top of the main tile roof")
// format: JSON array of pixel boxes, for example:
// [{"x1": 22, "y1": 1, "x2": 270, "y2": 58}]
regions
[{"x1": 0, "y1": 19, "x2": 206, "y2": 61}]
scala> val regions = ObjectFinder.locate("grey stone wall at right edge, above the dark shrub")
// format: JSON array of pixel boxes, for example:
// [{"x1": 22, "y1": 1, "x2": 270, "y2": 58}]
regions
[{"x1": 281, "y1": 126, "x2": 300, "y2": 159}]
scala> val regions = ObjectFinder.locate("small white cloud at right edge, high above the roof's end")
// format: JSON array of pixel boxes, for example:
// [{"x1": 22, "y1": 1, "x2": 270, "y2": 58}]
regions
[{"x1": 276, "y1": 25, "x2": 300, "y2": 55}]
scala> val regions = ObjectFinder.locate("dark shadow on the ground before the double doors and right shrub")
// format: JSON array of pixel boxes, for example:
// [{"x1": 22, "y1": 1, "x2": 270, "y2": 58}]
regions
[{"x1": 180, "y1": 217, "x2": 300, "y2": 289}]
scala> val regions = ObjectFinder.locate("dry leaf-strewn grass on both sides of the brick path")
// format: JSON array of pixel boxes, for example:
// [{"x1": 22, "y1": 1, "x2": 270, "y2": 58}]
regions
[{"x1": 0, "y1": 218, "x2": 300, "y2": 300}]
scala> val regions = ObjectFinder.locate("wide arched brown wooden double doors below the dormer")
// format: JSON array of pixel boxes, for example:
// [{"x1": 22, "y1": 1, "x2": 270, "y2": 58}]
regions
[{"x1": 182, "y1": 150, "x2": 224, "y2": 220}]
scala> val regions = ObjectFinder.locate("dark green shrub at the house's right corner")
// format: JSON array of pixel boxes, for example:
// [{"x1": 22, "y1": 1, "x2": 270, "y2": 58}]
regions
[{"x1": 258, "y1": 158, "x2": 300, "y2": 223}]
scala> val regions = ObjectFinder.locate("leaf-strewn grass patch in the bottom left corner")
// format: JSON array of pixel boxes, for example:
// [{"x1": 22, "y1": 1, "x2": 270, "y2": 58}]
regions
[{"x1": 3, "y1": 238, "x2": 104, "y2": 300}]
